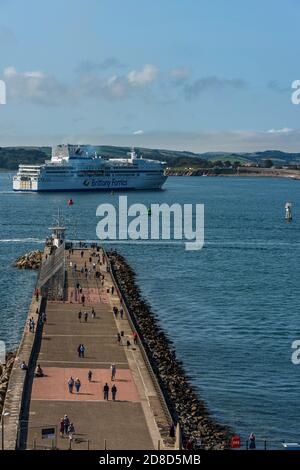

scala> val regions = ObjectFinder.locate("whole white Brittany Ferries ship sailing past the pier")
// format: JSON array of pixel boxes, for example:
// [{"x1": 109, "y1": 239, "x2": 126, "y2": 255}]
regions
[{"x1": 13, "y1": 144, "x2": 167, "y2": 191}]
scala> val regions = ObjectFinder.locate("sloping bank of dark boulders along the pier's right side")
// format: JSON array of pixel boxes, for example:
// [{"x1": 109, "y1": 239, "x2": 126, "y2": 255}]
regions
[{"x1": 107, "y1": 251, "x2": 230, "y2": 450}]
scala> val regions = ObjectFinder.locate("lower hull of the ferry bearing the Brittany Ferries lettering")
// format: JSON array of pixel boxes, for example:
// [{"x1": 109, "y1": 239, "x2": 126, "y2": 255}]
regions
[{"x1": 13, "y1": 175, "x2": 167, "y2": 192}]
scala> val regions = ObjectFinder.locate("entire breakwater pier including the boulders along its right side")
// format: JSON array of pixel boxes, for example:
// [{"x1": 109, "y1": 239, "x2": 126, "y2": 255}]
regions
[{"x1": 1, "y1": 222, "x2": 229, "y2": 450}]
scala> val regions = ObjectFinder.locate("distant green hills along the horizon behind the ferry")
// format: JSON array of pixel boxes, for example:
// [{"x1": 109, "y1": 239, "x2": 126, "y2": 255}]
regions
[{"x1": 0, "y1": 145, "x2": 300, "y2": 170}]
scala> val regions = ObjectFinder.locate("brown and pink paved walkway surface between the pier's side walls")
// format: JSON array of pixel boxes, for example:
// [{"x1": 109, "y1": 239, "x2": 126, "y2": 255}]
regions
[{"x1": 23, "y1": 249, "x2": 167, "y2": 450}]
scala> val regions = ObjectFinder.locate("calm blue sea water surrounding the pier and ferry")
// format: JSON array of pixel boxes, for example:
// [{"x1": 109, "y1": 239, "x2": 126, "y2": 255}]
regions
[{"x1": 0, "y1": 173, "x2": 300, "y2": 445}]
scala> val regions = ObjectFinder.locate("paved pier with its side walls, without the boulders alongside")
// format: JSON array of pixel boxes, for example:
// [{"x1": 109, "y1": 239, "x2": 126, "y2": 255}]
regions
[{"x1": 2, "y1": 226, "x2": 175, "y2": 450}]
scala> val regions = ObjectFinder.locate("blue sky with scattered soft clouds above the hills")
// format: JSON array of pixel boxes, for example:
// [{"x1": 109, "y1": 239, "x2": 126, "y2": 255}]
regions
[{"x1": 0, "y1": 0, "x2": 300, "y2": 152}]
